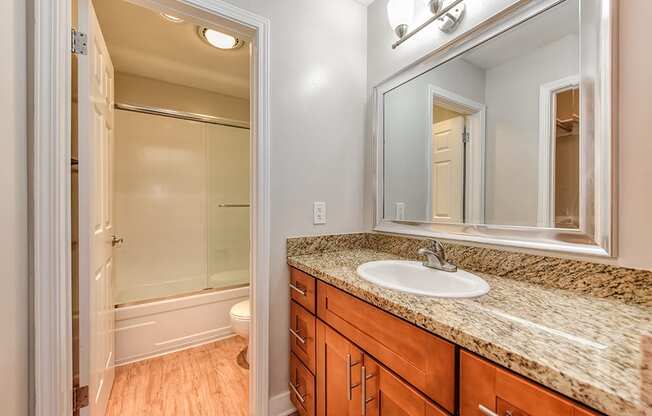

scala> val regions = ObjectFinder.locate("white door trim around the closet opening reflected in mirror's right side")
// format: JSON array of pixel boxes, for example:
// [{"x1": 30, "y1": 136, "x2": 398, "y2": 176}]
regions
[{"x1": 537, "y1": 75, "x2": 580, "y2": 228}]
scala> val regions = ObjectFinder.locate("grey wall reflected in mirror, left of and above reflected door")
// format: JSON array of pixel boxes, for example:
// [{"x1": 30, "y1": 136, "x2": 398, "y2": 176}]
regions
[{"x1": 384, "y1": 59, "x2": 485, "y2": 221}]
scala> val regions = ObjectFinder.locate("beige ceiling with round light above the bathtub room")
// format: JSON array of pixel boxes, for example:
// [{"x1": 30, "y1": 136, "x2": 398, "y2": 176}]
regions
[{"x1": 93, "y1": 0, "x2": 249, "y2": 98}]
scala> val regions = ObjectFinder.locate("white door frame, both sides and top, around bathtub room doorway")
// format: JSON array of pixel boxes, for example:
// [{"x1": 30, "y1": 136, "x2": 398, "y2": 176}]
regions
[{"x1": 28, "y1": 0, "x2": 270, "y2": 416}]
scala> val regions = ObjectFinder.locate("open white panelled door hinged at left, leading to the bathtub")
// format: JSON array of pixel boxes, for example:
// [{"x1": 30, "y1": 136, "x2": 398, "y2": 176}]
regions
[{"x1": 77, "y1": 0, "x2": 114, "y2": 416}]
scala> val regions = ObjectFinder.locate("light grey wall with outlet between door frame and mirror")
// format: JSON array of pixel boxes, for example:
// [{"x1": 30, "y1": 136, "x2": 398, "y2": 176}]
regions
[{"x1": 223, "y1": 0, "x2": 366, "y2": 397}]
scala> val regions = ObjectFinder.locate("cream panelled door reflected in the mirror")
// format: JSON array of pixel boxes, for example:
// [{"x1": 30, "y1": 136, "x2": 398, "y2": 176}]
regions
[{"x1": 431, "y1": 116, "x2": 464, "y2": 223}]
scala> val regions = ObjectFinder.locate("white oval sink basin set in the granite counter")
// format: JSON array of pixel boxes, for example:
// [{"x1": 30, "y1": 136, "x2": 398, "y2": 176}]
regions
[{"x1": 356, "y1": 260, "x2": 489, "y2": 298}]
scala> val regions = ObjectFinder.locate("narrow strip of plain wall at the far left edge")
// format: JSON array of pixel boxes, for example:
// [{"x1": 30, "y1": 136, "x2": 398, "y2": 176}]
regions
[{"x1": 0, "y1": 0, "x2": 29, "y2": 416}]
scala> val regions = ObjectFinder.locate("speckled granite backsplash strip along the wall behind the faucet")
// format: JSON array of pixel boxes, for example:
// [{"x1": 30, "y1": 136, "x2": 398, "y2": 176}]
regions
[{"x1": 287, "y1": 233, "x2": 652, "y2": 306}]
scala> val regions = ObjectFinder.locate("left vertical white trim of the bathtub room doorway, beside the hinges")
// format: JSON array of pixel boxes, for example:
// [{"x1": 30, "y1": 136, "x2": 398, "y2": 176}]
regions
[{"x1": 28, "y1": 0, "x2": 72, "y2": 416}]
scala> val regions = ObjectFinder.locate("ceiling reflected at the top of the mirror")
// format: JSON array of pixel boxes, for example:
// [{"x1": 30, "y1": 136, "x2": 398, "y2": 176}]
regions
[{"x1": 462, "y1": 0, "x2": 580, "y2": 69}]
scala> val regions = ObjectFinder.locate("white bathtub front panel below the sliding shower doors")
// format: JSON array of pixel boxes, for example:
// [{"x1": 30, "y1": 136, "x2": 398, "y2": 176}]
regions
[{"x1": 115, "y1": 286, "x2": 249, "y2": 365}]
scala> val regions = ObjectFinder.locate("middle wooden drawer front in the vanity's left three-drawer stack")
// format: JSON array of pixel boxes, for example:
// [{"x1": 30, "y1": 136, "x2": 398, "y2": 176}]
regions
[{"x1": 290, "y1": 301, "x2": 316, "y2": 374}]
